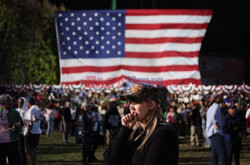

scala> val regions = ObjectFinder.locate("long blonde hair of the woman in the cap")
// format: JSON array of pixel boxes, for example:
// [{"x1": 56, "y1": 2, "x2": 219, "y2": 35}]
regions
[{"x1": 129, "y1": 98, "x2": 163, "y2": 150}]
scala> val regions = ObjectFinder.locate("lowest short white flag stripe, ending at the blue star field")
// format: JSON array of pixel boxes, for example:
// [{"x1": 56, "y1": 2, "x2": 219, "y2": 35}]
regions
[{"x1": 125, "y1": 43, "x2": 201, "y2": 52}]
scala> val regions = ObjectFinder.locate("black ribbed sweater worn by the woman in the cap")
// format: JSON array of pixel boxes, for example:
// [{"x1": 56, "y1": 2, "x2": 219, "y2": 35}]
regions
[{"x1": 104, "y1": 122, "x2": 179, "y2": 165}]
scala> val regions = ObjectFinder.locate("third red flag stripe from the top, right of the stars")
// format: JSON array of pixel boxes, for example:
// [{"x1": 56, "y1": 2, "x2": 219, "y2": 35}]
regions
[{"x1": 125, "y1": 37, "x2": 203, "y2": 44}]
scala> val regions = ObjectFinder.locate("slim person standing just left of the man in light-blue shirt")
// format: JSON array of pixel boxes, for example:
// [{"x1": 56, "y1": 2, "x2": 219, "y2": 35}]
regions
[{"x1": 200, "y1": 100, "x2": 211, "y2": 148}]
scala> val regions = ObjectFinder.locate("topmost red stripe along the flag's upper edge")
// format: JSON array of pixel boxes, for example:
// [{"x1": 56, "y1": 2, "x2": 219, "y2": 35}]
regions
[{"x1": 126, "y1": 9, "x2": 213, "y2": 16}]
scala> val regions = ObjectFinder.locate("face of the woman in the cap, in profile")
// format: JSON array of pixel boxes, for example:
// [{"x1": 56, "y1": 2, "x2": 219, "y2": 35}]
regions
[{"x1": 129, "y1": 101, "x2": 151, "y2": 122}]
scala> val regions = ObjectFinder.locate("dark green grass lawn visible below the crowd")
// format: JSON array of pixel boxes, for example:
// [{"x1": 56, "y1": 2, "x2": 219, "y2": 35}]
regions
[{"x1": 37, "y1": 131, "x2": 250, "y2": 165}]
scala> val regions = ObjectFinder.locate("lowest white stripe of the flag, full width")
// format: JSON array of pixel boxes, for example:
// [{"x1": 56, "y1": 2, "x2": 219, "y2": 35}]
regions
[{"x1": 62, "y1": 70, "x2": 200, "y2": 82}]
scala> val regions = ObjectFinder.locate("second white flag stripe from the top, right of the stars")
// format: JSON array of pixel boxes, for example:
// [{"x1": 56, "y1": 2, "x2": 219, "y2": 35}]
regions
[{"x1": 125, "y1": 29, "x2": 206, "y2": 38}]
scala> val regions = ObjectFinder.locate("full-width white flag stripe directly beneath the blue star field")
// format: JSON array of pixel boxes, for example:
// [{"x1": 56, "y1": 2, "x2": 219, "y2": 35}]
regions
[{"x1": 60, "y1": 57, "x2": 198, "y2": 67}]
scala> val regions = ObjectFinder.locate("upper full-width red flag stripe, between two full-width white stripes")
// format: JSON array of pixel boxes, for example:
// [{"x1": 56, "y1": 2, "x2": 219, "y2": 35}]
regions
[{"x1": 62, "y1": 65, "x2": 199, "y2": 74}]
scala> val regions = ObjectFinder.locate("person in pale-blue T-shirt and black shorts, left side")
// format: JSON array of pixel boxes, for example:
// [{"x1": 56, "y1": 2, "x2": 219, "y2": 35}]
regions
[{"x1": 24, "y1": 96, "x2": 42, "y2": 165}]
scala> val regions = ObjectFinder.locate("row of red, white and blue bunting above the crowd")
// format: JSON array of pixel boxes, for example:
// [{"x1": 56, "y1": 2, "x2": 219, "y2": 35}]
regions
[{"x1": 4, "y1": 83, "x2": 250, "y2": 94}]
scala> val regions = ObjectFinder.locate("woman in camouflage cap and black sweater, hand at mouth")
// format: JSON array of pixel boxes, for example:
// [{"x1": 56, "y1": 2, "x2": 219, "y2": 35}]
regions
[{"x1": 104, "y1": 83, "x2": 179, "y2": 165}]
